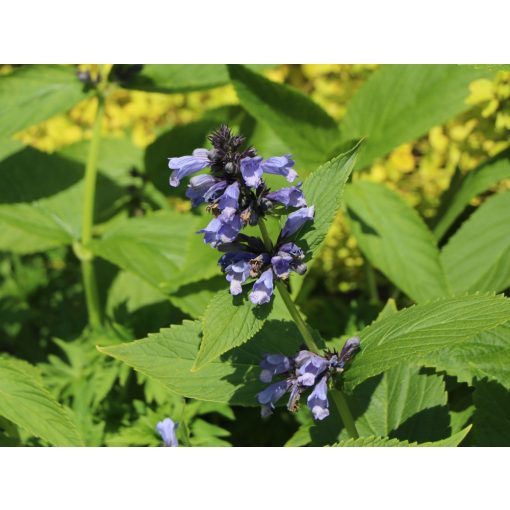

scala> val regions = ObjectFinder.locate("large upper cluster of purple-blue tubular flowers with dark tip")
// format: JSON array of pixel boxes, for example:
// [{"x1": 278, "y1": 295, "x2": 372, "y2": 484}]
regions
[{"x1": 168, "y1": 126, "x2": 314, "y2": 305}]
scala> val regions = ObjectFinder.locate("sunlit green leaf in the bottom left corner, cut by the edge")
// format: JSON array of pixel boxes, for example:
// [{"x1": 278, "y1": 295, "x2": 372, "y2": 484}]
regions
[{"x1": 0, "y1": 358, "x2": 82, "y2": 446}]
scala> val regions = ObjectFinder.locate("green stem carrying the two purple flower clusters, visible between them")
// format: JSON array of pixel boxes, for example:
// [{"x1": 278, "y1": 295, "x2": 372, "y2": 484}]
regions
[{"x1": 259, "y1": 220, "x2": 359, "y2": 439}]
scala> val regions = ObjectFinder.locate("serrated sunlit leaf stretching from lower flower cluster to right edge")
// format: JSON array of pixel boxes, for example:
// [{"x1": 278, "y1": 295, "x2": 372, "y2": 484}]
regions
[{"x1": 344, "y1": 294, "x2": 510, "y2": 388}]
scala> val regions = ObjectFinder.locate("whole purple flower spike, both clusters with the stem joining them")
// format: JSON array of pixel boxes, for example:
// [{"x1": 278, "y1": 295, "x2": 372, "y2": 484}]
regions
[{"x1": 168, "y1": 125, "x2": 360, "y2": 426}]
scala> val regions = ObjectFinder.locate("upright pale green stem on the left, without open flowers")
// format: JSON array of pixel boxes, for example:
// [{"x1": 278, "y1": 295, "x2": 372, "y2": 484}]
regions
[{"x1": 81, "y1": 94, "x2": 104, "y2": 328}]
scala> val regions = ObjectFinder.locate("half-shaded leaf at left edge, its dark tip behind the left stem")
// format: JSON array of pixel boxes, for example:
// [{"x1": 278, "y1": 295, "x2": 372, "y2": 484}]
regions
[{"x1": 0, "y1": 148, "x2": 124, "y2": 253}]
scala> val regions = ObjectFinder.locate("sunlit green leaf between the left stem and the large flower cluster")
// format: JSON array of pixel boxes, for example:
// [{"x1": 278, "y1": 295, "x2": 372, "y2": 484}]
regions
[{"x1": 92, "y1": 210, "x2": 218, "y2": 293}]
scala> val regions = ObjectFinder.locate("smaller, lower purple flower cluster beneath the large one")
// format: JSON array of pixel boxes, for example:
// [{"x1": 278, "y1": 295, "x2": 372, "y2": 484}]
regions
[{"x1": 257, "y1": 336, "x2": 360, "y2": 420}]
